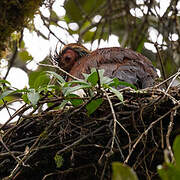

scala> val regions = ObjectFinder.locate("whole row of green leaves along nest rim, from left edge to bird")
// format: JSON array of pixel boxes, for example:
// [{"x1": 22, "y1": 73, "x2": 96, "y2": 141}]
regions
[{"x1": 0, "y1": 68, "x2": 135, "y2": 115}]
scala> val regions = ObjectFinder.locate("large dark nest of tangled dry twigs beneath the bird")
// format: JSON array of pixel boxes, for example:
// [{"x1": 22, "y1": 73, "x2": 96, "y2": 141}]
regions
[{"x1": 0, "y1": 87, "x2": 180, "y2": 180}]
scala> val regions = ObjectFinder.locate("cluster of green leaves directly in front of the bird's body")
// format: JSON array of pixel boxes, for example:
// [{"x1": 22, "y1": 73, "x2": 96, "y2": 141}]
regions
[{"x1": 48, "y1": 68, "x2": 132, "y2": 115}]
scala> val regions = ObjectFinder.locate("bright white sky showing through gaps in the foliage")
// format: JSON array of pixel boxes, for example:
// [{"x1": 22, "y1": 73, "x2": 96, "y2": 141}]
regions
[{"x1": 0, "y1": 0, "x2": 177, "y2": 123}]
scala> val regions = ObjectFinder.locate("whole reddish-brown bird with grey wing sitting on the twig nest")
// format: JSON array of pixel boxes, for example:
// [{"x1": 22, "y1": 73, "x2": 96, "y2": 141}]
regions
[{"x1": 54, "y1": 43, "x2": 158, "y2": 89}]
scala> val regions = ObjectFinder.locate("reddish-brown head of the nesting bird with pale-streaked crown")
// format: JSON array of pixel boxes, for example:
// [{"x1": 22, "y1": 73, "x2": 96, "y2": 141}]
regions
[{"x1": 56, "y1": 43, "x2": 90, "y2": 72}]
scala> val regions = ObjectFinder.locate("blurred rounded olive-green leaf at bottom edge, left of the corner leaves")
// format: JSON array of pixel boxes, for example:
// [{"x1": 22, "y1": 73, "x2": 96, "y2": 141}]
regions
[{"x1": 112, "y1": 162, "x2": 138, "y2": 180}]
